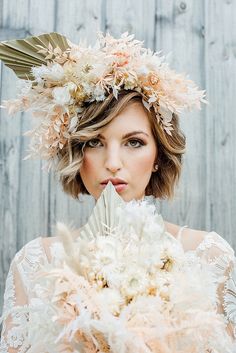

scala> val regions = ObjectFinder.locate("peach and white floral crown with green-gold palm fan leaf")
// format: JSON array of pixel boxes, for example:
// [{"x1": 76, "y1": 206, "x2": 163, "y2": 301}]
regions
[{"x1": 0, "y1": 32, "x2": 207, "y2": 170}]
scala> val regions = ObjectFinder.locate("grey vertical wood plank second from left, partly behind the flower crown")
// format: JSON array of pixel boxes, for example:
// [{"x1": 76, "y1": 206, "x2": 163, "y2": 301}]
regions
[{"x1": 17, "y1": 0, "x2": 55, "y2": 248}]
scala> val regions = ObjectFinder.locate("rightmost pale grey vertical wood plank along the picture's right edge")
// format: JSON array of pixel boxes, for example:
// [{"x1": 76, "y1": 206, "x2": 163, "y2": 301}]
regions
[{"x1": 205, "y1": 0, "x2": 236, "y2": 247}]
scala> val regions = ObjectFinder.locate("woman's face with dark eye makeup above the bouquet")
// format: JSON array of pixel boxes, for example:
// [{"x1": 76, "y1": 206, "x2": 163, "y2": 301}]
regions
[{"x1": 80, "y1": 102, "x2": 157, "y2": 201}]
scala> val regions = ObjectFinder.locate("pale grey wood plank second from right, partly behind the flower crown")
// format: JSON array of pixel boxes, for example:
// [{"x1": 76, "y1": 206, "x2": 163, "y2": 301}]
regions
[{"x1": 156, "y1": 0, "x2": 206, "y2": 229}]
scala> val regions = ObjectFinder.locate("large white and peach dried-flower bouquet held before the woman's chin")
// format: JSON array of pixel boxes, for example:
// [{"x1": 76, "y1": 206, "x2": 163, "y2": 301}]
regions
[{"x1": 25, "y1": 183, "x2": 232, "y2": 353}]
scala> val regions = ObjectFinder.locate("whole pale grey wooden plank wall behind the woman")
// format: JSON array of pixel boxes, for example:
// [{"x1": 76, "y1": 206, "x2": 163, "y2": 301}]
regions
[{"x1": 0, "y1": 0, "x2": 236, "y2": 314}]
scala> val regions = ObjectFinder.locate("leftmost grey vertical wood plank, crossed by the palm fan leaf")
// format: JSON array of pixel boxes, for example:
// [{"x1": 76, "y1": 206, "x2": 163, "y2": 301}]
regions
[{"x1": 0, "y1": 1, "x2": 28, "y2": 314}]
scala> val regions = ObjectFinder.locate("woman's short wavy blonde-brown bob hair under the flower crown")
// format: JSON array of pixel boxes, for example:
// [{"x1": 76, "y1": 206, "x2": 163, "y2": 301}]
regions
[{"x1": 56, "y1": 90, "x2": 185, "y2": 199}]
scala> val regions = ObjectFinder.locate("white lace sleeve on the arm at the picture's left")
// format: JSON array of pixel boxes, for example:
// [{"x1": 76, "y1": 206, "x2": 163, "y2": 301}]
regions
[{"x1": 0, "y1": 237, "x2": 46, "y2": 353}]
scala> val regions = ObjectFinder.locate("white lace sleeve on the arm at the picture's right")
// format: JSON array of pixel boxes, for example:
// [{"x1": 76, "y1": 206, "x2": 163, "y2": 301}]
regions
[{"x1": 197, "y1": 232, "x2": 236, "y2": 344}]
